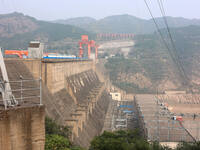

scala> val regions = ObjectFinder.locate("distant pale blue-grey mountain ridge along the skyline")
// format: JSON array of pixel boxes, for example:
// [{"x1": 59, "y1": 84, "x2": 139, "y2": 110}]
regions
[{"x1": 52, "y1": 14, "x2": 200, "y2": 34}]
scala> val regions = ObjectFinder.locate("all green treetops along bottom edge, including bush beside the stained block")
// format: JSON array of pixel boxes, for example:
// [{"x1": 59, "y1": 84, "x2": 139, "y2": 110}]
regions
[{"x1": 45, "y1": 118, "x2": 200, "y2": 150}]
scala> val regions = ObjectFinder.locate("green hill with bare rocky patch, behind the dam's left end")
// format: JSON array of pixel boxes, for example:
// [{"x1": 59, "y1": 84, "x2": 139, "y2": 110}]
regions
[{"x1": 0, "y1": 13, "x2": 92, "y2": 49}]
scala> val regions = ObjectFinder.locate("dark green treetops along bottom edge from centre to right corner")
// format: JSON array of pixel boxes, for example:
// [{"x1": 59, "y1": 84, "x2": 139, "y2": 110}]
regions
[{"x1": 90, "y1": 130, "x2": 200, "y2": 150}]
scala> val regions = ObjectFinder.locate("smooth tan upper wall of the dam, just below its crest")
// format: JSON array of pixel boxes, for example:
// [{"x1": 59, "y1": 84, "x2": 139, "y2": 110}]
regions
[{"x1": 22, "y1": 59, "x2": 94, "y2": 93}]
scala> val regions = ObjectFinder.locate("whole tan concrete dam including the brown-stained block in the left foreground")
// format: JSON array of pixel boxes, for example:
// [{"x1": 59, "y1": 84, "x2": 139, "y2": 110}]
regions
[{"x1": 0, "y1": 58, "x2": 110, "y2": 150}]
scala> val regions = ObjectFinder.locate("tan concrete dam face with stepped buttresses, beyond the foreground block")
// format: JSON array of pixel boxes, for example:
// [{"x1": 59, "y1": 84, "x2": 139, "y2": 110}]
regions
[{"x1": 23, "y1": 59, "x2": 110, "y2": 148}]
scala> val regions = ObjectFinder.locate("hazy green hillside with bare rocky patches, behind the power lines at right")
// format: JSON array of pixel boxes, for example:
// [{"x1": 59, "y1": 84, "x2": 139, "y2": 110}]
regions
[{"x1": 106, "y1": 26, "x2": 200, "y2": 93}]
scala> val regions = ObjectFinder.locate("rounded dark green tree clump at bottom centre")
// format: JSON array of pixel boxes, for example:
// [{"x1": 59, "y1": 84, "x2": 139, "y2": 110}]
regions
[{"x1": 90, "y1": 130, "x2": 150, "y2": 150}]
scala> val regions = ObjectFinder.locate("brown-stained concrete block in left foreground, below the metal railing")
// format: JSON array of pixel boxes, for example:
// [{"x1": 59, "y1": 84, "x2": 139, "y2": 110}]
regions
[{"x1": 0, "y1": 106, "x2": 45, "y2": 150}]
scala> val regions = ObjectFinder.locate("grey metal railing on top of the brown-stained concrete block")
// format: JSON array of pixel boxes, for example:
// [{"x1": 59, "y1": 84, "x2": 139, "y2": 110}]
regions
[{"x1": 0, "y1": 78, "x2": 42, "y2": 109}]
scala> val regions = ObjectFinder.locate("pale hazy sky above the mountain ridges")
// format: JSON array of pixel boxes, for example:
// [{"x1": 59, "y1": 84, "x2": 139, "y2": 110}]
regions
[{"x1": 0, "y1": 0, "x2": 200, "y2": 20}]
